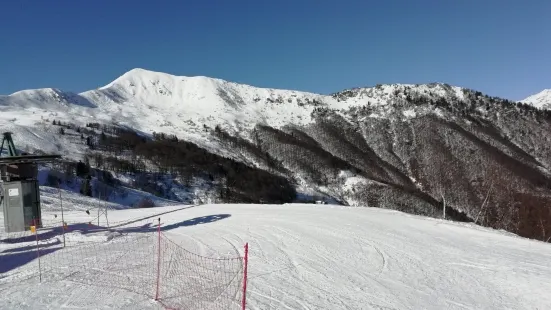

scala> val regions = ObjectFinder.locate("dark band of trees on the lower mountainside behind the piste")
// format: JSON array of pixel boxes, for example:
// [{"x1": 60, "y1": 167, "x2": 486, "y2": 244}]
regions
[{"x1": 80, "y1": 128, "x2": 296, "y2": 203}]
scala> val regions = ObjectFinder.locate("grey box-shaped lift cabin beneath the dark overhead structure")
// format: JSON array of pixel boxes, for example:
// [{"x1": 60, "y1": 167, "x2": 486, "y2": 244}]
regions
[{"x1": 2, "y1": 180, "x2": 42, "y2": 233}]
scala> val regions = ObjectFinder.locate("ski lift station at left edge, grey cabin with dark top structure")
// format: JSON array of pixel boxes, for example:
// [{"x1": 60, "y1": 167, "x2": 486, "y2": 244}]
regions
[{"x1": 0, "y1": 132, "x2": 61, "y2": 233}]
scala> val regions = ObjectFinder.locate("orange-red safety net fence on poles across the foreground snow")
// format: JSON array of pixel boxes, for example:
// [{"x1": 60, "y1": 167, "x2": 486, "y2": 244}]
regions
[{"x1": 0, "y1": 219, "x2": 248, "y2": 309}]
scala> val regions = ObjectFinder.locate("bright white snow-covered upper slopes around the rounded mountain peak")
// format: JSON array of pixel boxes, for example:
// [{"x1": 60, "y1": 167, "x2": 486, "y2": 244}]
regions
[{"x1": 0, "y1": 69, "x2": 470, "y2": 155}]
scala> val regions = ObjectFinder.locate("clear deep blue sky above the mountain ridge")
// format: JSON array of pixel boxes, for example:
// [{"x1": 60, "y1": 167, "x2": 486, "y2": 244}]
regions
[{"x1": 0, "y1": 0, "x2": 551, "y2": 100}]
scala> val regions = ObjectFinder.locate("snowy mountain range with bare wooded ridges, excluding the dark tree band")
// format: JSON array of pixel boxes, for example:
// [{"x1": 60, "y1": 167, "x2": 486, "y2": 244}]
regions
[{"x1": 0, "y1": 69, "x2": 551, "y2": 240}]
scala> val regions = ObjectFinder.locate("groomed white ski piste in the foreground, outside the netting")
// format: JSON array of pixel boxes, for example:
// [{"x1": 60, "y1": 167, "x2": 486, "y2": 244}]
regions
[{"x1": 0, "y1": 200, "x2": 551, "y2": 310}]
